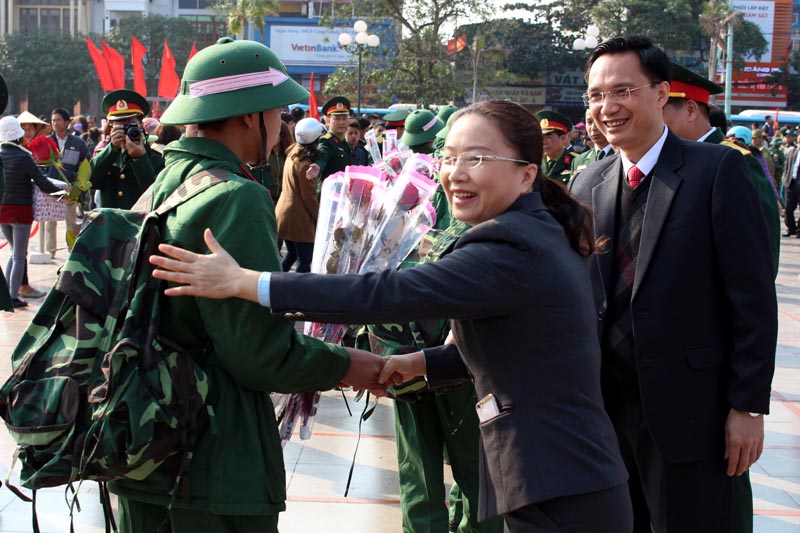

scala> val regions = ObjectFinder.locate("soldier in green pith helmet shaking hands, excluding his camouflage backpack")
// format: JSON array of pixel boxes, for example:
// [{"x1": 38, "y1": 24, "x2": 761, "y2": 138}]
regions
[{"x1": 109, "y1": 38, "x2": 381, "y2": 533}]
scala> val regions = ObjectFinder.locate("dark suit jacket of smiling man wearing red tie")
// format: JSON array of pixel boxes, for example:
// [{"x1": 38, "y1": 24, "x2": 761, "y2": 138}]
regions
[{"x1": 572, "y1": 133, "x2": 778, "y2": 462}]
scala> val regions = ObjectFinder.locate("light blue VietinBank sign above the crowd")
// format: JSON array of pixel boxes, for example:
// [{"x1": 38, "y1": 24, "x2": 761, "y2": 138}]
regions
[{"x1": 269, "y1": 25, "x2": 353, "y2": 66}]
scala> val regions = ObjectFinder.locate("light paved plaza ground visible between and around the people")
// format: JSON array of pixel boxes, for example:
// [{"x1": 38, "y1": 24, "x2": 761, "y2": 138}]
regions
[{"x1": 0, "y1": 222, "x2": 800, "y2": 533}]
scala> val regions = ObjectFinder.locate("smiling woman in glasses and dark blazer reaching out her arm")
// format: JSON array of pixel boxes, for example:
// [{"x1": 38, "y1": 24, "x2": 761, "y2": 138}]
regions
[{"x1": 151, "y1": 101, "x2": 632, "y2": 533}]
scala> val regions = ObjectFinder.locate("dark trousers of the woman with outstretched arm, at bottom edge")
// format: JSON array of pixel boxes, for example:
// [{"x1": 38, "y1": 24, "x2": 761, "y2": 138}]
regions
[{"x1": 503, "y1": 483, "x2": 633, "y2": 533}]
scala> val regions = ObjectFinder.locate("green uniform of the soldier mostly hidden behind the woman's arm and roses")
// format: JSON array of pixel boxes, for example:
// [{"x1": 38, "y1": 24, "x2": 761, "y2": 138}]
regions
[{"x1": 358, "y1": 186, "x2": 503, "y2": 533}]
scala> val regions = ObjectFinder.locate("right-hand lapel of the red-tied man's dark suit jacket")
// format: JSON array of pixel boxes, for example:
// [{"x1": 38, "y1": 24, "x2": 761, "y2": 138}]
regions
[{"x1": 631, "y1": 132, "x2": 683, "y2": 300}]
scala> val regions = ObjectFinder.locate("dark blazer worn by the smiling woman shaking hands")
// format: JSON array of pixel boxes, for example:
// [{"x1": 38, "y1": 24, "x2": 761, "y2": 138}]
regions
[{"x1": 270, "y1": 193, "x2": 627, "y2": 519}]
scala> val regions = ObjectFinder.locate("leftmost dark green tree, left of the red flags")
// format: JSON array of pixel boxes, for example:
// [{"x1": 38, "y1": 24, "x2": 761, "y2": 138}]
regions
[{"x1": 0, "y1": 32, "x2": 97, "y2": 117}]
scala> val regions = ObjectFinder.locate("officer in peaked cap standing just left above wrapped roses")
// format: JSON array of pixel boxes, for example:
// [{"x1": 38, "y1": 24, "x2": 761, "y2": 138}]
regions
[{"x1": 306, "y1": 96, "x2": 353, "y2": 182}]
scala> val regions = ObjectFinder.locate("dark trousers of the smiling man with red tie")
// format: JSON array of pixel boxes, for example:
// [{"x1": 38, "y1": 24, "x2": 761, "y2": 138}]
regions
[{"x1": 606, "y1": 400, "x2": 733, "y2": 533}]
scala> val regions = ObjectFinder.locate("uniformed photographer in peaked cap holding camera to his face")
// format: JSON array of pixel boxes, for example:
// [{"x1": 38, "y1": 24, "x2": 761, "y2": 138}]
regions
[{"x1": 90, "y1": 89, "x2": 164, "y2": 209}]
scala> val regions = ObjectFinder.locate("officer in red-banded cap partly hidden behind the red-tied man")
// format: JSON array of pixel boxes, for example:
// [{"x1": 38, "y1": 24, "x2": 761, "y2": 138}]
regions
[{"x1": 664, "y1": 63, "x2": 781, "y2": 278}]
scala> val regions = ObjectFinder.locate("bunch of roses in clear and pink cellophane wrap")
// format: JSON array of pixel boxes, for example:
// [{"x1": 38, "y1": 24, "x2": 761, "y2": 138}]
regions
[{"x1": 272, "y1": 147, "x2": 437, "y2": 444}]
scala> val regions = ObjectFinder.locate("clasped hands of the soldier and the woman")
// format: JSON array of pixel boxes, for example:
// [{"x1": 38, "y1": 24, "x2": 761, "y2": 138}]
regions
[{"x1": 340, "y1": 348, "x2": 426, "y2": 397}]
